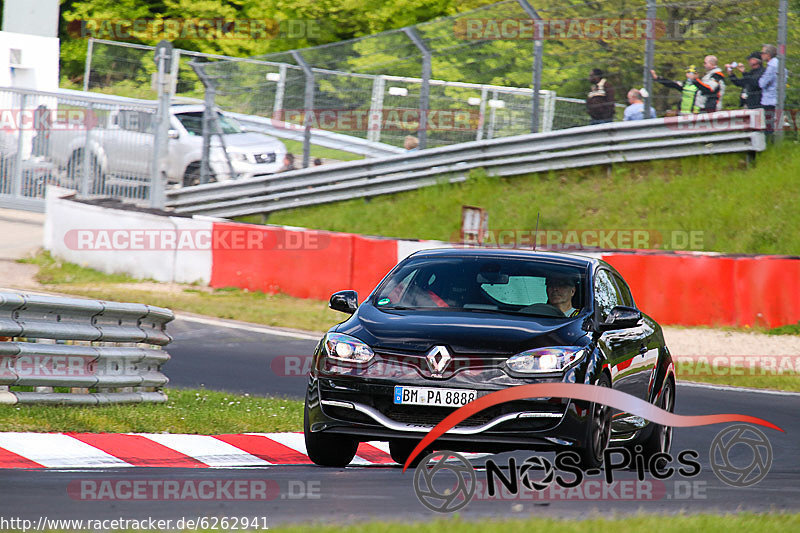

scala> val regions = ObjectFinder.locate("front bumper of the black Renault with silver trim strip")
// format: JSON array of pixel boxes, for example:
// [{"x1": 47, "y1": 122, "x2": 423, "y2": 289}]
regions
[{"x1": 306, "y1": 374, "x2": 590, "y2": 451}]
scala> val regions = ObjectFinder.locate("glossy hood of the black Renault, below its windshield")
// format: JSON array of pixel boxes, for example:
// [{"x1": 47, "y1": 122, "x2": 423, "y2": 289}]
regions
[{"x1": 336, "y1": 304, "x2": 589, "y2": 355}]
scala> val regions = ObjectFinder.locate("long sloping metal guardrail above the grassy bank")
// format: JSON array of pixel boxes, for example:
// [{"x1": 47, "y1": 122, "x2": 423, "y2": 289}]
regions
[{"x1": 167, "y1": 109, "x2": 766, "y2": 217}]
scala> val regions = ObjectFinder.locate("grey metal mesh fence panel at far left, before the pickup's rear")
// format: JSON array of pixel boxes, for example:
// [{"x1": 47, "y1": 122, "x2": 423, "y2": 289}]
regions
[{"x1": 0, "y1": 89, "x2": 156, "y2": 208}]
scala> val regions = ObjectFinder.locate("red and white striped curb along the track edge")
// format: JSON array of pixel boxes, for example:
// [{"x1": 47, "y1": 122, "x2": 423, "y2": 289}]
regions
[{"x1": 0, "y1": 433, "x2": 483, "y2": 468}]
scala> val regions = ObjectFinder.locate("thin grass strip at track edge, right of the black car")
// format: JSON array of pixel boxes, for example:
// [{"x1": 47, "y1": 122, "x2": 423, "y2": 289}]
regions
[{"x1": 675, "y1": 361, "x2": 800, "y2": 392}]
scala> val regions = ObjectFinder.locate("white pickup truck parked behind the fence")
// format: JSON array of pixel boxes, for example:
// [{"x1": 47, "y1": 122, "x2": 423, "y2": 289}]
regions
[{"x1": 48, "y1": 104, "x2": 286, "y2": 194}]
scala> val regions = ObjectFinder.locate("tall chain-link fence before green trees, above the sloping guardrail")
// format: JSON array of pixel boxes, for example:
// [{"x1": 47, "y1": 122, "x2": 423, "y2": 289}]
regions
[{"x1": 79, "y1": 0, "x2": 800, "y2": 166}]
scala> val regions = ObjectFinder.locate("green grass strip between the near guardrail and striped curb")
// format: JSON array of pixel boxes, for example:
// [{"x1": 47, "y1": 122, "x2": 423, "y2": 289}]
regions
[{"x1": 0, "y1": 389, "x2": 303, "y2": 435}]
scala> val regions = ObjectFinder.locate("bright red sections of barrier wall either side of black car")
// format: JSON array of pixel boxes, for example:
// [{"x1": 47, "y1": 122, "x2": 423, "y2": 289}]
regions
[{"x1": 210, "y1": 217, "x2": 800, "y2": 327}]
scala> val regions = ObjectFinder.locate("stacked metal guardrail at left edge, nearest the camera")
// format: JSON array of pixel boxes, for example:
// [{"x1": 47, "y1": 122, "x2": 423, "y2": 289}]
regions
[{"x1": 0, "y1": 293, "x2": 174, "y2": 405}]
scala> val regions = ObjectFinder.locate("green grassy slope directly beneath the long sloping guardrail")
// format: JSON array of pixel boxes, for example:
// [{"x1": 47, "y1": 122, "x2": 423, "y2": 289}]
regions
[{"x1": 268, "y1": 142, "x2": 800, "y2": 254}]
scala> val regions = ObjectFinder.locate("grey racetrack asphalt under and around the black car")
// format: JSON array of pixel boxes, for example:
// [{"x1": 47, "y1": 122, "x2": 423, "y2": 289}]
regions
[{"x1": 0, "y1": 318, "x2": 800, "y2": 526}]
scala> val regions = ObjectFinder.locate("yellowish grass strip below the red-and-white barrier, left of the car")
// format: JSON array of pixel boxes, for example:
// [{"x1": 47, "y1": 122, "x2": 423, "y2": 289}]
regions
[{"x1": 22, "y1": 252, "x2": 338, "y2": 331}]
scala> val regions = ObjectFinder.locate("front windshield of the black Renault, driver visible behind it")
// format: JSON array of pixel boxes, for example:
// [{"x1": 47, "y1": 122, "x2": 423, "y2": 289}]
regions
[{"x1": 373, "y1": 257, "x2": 586, "y2": 318}]
